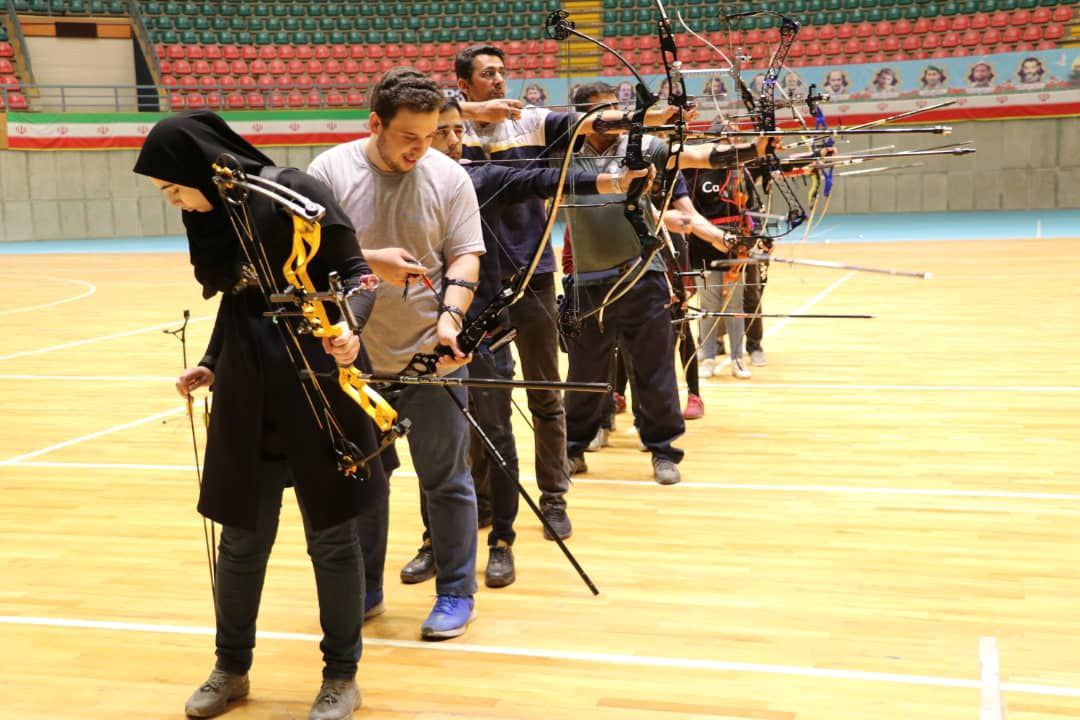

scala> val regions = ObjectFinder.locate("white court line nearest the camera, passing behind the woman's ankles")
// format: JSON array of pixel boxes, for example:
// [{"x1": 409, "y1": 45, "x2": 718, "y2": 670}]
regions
[{"x1": 0, "y1": 615, "x2": 1080, "y2": 697}]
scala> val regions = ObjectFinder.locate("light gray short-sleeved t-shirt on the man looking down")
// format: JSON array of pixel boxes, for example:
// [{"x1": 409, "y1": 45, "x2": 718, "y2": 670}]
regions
[{"x1": 308, "y1": 140, "x2": 484, "y2": 373}]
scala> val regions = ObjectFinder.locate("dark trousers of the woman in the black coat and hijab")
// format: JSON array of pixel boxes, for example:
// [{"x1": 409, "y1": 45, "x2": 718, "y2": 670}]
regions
[{"x1": 214, "y1": 461, "x2": 364, "y2": 679}]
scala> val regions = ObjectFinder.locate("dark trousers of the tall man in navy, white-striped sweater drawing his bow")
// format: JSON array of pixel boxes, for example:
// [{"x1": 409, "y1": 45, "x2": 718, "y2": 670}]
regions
[{"x1": 510, "y1": 272, "x2": 574, "y2": 505}]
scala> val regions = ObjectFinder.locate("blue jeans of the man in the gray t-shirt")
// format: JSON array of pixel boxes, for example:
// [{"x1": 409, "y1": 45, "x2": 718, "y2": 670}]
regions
[{"x1": 357, "y1": 368, "x2": 476, "y2": 597}]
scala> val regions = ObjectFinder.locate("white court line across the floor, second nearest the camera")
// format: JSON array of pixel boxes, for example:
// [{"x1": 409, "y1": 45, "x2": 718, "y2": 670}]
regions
[{"x1": 5, "y1": 460, "x2": 1080, "y2": 502}]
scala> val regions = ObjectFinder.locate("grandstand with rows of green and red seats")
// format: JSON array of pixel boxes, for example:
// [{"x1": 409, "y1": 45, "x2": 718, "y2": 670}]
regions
[{"x1": 0, "y1": 0, "x2": 1080, "y2": 110}]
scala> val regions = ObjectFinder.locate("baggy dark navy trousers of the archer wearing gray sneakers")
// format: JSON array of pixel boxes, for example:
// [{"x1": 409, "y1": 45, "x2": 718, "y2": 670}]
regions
[{"x1": 566, "y1": 271, "x2": 686, "y2": 462}]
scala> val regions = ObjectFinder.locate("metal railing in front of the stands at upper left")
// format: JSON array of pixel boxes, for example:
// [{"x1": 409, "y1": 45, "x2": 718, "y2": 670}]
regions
[{"x1": 0, "y1": 84, "x2": 368, "y2": 112}]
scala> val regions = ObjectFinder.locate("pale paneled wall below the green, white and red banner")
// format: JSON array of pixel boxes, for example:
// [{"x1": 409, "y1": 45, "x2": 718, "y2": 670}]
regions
[{"x1": 0, "y1": 118, "x2": 1080, "y2": 242}]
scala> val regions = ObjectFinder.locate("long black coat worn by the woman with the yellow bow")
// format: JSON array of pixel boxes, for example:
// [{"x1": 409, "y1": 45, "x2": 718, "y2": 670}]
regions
[{"x1": 199, "y1": 169, "x2": 397, "y2": 529}]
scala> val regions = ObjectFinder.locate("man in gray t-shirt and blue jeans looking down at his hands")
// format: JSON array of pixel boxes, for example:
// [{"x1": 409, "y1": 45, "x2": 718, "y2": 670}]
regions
[{"x1": 308, "y1": 68, "x2": 484, "y2": 639}]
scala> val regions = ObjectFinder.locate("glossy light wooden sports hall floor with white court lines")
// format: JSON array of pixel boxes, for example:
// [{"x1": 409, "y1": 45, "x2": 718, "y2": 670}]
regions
[{"x1": 0, "y1": 241, "x2": 1080, "y2": 720}]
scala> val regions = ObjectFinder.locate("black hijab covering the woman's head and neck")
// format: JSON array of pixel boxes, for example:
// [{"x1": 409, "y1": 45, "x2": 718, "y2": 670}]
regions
[{"x1": 134, "y1": 110, "x2": 274, "y2": 298}]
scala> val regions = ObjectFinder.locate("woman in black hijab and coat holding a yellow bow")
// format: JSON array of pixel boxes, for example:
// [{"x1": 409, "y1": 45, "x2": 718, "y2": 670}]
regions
[{"x1": 135, "y1": 111, "x2": 397, "y2": 720}]
